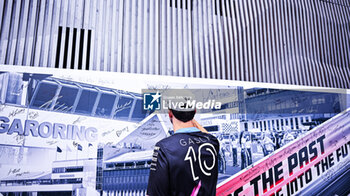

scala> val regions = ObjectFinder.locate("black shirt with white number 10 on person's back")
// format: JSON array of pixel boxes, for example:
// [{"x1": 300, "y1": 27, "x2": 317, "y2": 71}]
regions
[{"x1": 147, "y1": 127, "x2": 219, "y2": 196}]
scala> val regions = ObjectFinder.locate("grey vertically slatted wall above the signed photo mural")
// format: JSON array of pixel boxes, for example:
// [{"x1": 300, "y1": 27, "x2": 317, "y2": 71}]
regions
[{"x1": 0, "y1": 0, "x2": 350, "y2": 88}]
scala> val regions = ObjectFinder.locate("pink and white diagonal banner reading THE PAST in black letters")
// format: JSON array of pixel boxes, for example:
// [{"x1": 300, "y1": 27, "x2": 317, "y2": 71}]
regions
[{"x1": 217, "y1": 109, "x2": 350, "y2": 196}]
